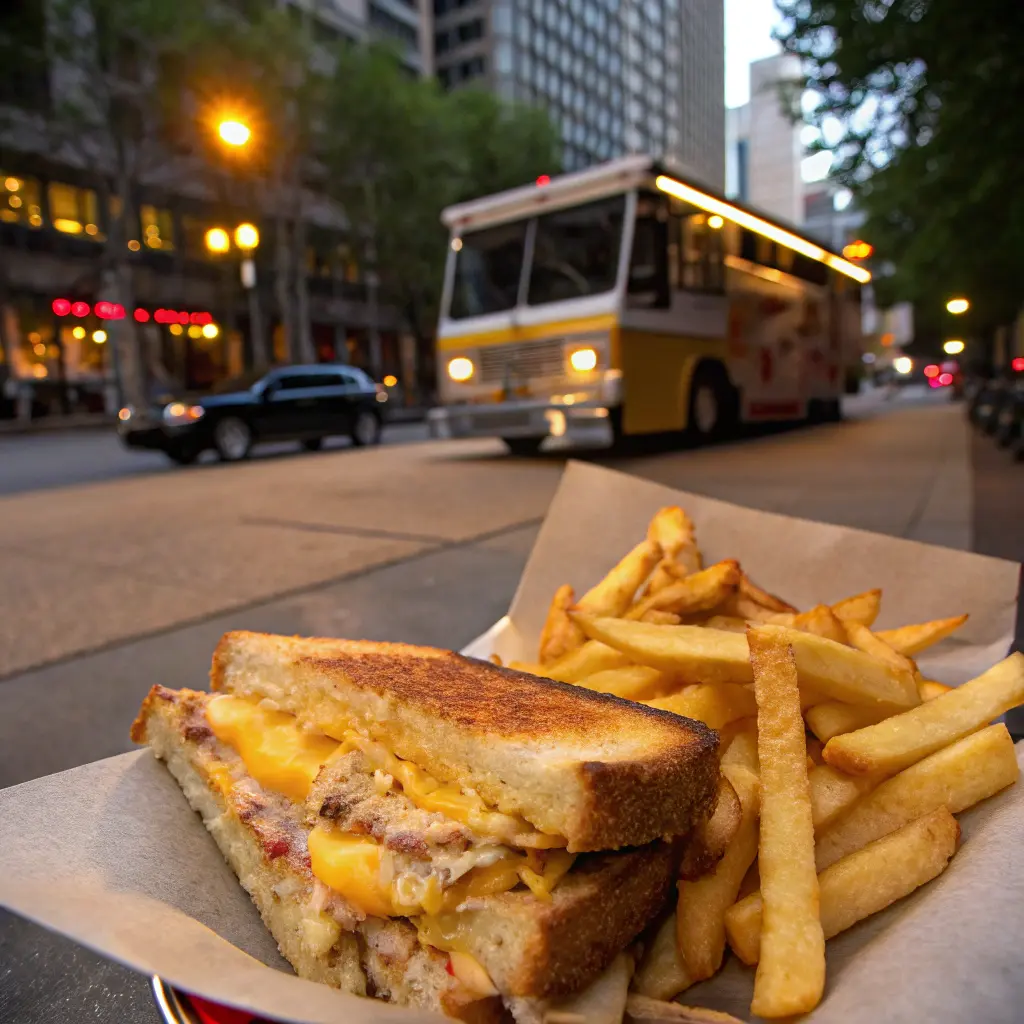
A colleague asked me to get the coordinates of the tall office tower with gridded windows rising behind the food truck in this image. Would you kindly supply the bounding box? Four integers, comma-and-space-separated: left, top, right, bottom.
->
434, 0, 725, 188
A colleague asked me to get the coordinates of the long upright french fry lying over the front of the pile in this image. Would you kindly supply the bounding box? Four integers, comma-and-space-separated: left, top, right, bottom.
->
749, 627, 827, 1017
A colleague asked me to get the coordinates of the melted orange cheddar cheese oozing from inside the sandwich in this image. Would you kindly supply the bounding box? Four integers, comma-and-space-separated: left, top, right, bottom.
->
206, 695, 574, 917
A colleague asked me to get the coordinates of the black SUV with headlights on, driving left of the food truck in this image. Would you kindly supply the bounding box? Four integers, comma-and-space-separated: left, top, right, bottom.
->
118, 365, 387, 465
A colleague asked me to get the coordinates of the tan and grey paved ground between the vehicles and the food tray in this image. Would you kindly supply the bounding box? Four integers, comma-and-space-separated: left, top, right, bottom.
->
0, 393, 1024, 1024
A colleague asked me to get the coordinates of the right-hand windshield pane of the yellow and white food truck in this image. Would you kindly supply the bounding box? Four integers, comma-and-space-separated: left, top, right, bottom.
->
526, 196, 626, 306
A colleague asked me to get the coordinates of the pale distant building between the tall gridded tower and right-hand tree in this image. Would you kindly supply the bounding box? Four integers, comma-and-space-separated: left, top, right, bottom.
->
725, 54, 804, 224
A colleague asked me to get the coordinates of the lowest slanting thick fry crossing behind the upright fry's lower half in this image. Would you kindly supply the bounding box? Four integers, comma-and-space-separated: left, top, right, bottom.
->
725, 807, 959, 965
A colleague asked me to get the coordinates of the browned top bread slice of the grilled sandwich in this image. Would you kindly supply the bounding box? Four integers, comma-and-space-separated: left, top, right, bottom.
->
210, 632, 718, 853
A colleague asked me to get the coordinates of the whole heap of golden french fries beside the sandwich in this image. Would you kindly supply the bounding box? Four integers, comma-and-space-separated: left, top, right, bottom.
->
499, 507, 1024, 1020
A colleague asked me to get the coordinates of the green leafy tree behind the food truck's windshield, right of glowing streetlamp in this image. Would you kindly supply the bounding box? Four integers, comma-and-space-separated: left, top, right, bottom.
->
322, 45, 558, 373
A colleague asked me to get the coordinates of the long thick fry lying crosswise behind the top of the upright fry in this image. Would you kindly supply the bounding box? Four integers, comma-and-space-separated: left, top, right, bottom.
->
570, 612, 921, 710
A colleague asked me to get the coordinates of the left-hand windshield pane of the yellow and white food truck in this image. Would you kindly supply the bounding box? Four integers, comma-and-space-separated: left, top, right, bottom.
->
450, 220, 527, 319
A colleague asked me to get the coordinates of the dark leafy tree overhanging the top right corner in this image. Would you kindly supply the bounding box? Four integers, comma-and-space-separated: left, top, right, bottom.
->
776, 0, 1024, 339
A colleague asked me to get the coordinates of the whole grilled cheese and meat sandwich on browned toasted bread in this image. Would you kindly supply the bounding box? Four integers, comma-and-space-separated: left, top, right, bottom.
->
132, 632, 718, 1020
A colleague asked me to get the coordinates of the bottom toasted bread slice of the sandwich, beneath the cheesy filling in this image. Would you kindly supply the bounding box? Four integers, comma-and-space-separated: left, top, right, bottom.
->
132, 686, 679, 999
